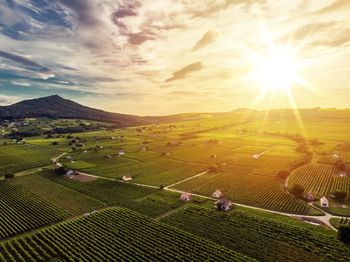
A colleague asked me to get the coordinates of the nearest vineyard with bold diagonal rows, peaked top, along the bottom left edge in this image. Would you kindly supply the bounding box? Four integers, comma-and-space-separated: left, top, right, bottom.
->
0, 208, 252, 262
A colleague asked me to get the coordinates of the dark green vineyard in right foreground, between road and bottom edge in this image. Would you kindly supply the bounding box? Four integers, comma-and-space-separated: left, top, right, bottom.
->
161, 206, 350, 261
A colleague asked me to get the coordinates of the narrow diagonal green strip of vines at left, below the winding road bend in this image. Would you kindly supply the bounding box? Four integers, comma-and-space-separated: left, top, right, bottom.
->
15, 174, 106, 216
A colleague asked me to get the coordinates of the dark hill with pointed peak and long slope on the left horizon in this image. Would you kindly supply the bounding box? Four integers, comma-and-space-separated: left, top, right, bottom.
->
0, 95, 180, 127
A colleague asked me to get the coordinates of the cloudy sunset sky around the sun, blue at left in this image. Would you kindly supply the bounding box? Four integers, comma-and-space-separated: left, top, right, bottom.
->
0, 0, 350, 115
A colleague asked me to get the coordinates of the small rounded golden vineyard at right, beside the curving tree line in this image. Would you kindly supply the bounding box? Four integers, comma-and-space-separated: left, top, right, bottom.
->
288, 164, 334, 197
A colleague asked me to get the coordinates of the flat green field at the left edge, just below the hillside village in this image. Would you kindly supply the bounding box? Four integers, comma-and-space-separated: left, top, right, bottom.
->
0, 144, 57, 176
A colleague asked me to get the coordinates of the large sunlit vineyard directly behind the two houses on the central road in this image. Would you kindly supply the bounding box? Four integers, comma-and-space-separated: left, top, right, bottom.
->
175, 167, 314, 214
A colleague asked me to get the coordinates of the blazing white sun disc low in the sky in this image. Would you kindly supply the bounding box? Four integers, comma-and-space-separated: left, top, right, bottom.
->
251, 48, 301, 92
